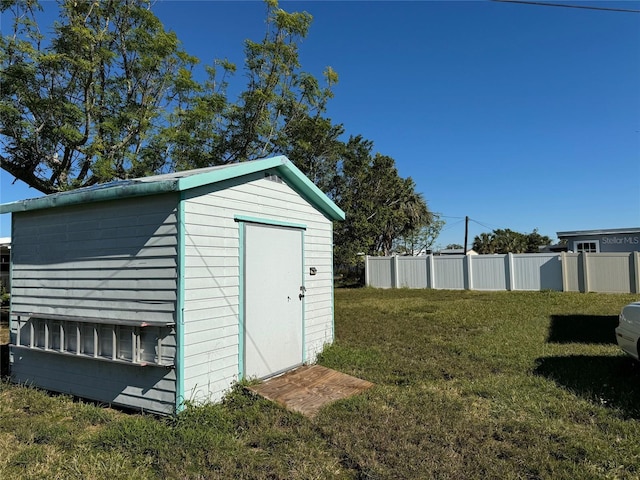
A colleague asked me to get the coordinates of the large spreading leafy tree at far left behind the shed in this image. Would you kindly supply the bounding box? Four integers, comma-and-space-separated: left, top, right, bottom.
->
0, 0, 196, 193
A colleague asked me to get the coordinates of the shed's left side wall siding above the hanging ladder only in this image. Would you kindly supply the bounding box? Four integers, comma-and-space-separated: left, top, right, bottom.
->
12, 195, 177, 322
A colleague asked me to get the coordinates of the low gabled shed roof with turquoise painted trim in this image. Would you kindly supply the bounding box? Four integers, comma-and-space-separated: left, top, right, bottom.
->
0, 156, 345, 220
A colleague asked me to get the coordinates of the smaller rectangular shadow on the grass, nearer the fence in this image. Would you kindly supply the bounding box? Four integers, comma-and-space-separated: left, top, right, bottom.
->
547, 315, 618, 345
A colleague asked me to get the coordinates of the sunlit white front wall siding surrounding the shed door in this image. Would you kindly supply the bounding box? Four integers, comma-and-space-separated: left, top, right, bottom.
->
184, 173, 333, 401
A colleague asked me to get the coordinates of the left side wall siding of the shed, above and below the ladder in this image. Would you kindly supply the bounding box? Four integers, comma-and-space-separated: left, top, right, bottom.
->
11, 194, 178, 413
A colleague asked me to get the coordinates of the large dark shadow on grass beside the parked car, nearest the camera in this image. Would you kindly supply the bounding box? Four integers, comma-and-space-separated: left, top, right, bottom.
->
534, 355, 640, 419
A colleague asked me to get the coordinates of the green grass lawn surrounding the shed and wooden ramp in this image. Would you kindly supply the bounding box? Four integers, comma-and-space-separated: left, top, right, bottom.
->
0, 289, 640, 480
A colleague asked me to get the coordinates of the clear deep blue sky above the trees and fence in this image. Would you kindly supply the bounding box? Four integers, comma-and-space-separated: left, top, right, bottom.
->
0, 0, 640, 246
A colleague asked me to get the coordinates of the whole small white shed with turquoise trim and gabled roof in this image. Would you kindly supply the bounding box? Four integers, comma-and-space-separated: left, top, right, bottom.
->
0, 157, 344, 413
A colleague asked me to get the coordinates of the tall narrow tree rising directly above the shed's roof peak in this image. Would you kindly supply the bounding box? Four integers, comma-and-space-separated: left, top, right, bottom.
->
215, 0, 342, 163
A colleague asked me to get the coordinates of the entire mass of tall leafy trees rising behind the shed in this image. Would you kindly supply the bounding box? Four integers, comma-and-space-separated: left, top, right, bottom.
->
0, 0, 430, 272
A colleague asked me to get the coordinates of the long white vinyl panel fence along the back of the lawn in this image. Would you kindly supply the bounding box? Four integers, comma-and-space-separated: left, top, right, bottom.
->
365, 252, 640, 293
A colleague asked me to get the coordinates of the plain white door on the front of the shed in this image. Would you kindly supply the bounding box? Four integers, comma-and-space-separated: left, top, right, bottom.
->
244, 223, 303, 378
